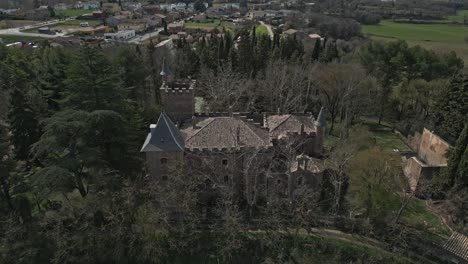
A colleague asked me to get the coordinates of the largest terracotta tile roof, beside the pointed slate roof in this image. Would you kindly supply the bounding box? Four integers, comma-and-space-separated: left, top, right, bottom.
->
182, 117, 270, 149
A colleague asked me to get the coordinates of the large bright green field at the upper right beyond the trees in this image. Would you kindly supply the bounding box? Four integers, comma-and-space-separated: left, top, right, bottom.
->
362, 19, 468, 64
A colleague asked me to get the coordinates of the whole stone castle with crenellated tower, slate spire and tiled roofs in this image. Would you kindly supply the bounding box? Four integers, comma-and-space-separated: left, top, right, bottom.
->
141, 63, 326, 200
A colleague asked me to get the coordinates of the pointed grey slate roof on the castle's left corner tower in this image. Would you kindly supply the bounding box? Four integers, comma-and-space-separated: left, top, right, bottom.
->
141, 112, 185, 152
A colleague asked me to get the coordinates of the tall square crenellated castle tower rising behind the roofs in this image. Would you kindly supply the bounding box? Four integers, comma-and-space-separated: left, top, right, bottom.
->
159, 60, 196, 123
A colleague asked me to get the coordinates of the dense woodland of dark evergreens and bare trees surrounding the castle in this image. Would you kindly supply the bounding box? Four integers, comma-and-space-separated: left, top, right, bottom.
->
0, 21, 468, 263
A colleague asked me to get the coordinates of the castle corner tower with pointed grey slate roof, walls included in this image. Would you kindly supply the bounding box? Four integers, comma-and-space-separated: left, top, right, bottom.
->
141, 112, 185, 181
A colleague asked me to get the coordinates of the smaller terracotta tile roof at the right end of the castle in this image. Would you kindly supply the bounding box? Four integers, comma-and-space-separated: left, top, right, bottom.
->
265, 114, 317, 137
